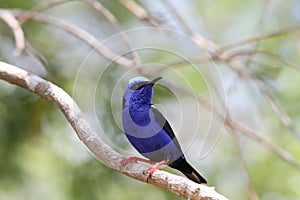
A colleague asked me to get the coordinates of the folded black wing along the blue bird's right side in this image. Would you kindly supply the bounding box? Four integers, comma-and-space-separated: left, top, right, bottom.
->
151, 106, 182, 152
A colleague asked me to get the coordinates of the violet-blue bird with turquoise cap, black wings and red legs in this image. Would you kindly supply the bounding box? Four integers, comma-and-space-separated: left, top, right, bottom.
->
121, 77, 207, 183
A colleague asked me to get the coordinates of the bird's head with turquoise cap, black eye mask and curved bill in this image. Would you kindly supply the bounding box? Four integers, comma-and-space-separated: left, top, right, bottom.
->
123, 76, 162, 107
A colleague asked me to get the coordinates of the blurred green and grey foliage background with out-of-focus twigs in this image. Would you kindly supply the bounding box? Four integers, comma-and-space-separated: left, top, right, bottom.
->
0, 0, 300, 200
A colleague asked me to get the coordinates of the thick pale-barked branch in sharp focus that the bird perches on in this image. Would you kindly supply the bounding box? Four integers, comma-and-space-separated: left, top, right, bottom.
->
0, 61, 227, 200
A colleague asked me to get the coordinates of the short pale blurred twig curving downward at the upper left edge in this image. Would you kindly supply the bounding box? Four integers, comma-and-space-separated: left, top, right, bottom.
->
0, 9, 25, 56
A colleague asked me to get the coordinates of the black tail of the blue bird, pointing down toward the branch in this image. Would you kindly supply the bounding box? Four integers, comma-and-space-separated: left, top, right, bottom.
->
169, 157, 207, 183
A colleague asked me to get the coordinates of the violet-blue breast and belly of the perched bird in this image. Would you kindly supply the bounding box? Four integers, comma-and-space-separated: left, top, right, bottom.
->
122, 108, 182, 162
